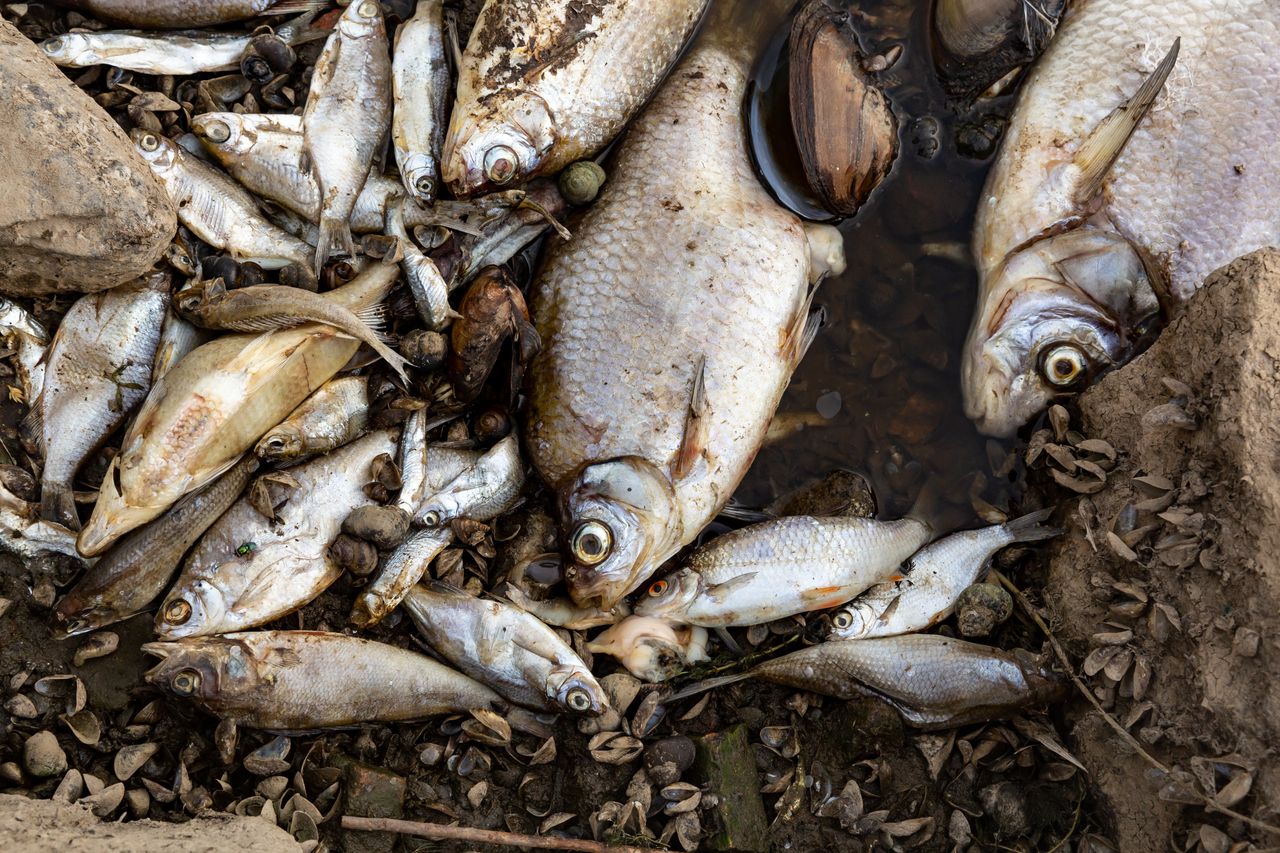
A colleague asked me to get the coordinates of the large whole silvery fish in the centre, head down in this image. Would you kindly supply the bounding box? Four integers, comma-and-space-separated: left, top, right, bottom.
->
526, 0, 844, 610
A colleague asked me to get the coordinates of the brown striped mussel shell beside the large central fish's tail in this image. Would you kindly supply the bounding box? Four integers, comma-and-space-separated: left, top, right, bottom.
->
788, 0, 897, 216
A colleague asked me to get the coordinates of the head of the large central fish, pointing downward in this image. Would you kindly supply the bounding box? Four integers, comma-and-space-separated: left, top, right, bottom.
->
563, 456, 680, 610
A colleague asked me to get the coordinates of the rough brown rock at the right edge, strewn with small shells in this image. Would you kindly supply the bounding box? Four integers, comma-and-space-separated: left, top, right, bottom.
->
1046, 244, 1280, 850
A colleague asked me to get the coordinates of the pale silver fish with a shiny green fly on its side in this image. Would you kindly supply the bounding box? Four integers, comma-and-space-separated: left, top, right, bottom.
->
156, 429, 397, 639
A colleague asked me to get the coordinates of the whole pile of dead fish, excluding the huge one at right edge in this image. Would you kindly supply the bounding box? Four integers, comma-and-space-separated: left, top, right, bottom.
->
0, 0, 1111, 768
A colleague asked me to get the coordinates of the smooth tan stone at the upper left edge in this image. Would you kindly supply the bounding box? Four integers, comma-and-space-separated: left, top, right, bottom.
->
0, 20, 177, 296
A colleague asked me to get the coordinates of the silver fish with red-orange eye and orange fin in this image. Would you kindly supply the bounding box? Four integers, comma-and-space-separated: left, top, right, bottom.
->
635, 515, 933, 628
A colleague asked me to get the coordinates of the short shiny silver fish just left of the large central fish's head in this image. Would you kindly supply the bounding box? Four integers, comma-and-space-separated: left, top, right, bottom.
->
413, 434, 525, 528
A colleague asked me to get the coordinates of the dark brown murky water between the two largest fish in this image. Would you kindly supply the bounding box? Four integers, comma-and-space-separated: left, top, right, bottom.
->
737, 0, 1012, 521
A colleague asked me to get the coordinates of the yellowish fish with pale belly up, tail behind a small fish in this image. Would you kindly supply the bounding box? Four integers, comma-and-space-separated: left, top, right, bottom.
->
79, 264, 396, 556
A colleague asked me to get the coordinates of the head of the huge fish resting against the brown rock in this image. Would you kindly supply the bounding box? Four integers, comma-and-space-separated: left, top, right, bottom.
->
961, 228, 1160, 437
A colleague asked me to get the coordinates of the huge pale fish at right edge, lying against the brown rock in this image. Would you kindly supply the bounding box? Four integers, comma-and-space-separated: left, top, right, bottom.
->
963, 0, 1280, 435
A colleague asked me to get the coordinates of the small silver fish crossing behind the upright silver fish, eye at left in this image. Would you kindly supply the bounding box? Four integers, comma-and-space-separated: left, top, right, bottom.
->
191, 113, 409, 234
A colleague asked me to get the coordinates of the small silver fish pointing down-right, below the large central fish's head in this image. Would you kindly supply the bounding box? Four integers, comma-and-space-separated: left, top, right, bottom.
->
404, 580, 609, 717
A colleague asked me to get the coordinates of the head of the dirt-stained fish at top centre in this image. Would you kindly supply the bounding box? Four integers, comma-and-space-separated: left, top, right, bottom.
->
442, 92, 556, 199
